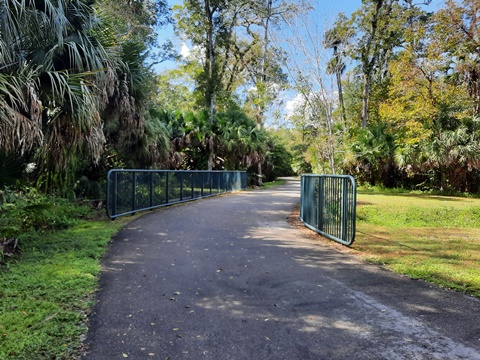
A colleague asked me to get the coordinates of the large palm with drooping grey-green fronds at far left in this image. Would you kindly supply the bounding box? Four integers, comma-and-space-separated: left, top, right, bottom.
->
0, 0, 120, 194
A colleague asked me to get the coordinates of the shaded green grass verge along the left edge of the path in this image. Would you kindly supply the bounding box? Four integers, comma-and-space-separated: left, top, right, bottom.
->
0, 218, 131, 360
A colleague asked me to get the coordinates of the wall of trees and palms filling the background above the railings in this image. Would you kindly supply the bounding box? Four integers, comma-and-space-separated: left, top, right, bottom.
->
0, 0, 480, 196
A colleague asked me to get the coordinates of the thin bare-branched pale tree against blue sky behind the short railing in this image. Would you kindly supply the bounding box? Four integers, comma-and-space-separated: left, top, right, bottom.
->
282, 3, 341, 174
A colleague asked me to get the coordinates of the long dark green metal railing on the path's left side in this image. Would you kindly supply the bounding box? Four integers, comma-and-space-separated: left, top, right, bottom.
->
106, 169, 247, 219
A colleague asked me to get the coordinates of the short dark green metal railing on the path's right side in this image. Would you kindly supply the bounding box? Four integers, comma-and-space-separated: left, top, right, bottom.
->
300, 174, 357, 245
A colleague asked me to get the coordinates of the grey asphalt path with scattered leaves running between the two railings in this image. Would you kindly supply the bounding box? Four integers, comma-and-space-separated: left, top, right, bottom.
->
85, 181, 480, 360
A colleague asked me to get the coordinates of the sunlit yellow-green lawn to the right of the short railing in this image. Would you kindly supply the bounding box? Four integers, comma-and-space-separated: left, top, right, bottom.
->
352, 192, 480, 297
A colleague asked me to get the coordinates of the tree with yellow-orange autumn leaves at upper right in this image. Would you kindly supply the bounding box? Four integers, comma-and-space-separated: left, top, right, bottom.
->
380, 11, 440, 144
